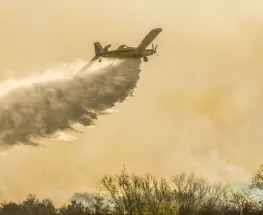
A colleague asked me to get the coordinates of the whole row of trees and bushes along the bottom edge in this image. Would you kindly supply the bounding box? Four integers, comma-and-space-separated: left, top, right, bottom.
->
0, 165, 263, 215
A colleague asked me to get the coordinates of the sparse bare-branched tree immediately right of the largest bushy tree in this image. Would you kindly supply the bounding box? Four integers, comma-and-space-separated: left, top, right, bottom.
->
173, 173, 227, 215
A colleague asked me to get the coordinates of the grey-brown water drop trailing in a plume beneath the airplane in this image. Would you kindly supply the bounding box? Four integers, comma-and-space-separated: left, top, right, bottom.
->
0, 59, 141, 145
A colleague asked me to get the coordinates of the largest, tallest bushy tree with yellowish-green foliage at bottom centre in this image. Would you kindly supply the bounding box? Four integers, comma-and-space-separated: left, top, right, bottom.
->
101, 169, 176, 215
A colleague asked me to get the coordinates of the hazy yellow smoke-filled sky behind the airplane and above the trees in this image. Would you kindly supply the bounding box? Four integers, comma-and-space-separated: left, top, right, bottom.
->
0, 0, 263, 203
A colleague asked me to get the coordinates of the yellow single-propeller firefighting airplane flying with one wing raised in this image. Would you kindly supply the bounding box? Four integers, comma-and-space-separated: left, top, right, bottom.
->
91, 28, 162, 62
